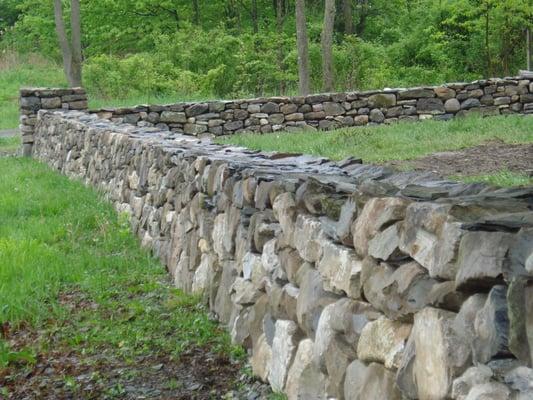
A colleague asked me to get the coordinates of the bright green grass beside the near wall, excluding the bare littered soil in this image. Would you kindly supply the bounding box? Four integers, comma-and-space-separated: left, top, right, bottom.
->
0, 158, 239, 369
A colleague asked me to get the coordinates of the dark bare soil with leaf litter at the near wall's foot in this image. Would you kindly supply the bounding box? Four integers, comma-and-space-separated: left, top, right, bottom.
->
0, 292, 271, 400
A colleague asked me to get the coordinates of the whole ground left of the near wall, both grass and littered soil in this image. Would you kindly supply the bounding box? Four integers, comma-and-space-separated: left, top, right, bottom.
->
0, 158, 264, 399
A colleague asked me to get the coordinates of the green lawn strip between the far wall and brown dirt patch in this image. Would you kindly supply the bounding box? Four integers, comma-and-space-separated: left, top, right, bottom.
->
218, 116, 533, 163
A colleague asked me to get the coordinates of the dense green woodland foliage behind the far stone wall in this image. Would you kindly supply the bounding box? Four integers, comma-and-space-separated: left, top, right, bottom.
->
0, 0, 533, 98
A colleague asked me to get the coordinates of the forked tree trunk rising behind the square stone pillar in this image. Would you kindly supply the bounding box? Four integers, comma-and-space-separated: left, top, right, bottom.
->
54, 0, 82, 87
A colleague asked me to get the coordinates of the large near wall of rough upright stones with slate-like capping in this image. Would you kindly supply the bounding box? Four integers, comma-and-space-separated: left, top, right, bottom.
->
34, 111, 533, 400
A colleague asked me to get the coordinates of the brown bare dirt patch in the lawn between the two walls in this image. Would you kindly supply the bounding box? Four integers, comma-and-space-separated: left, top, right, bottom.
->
388, 141, 533, 177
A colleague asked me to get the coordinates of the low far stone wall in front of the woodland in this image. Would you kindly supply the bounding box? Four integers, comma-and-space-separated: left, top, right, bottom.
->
92, 77, 533, 135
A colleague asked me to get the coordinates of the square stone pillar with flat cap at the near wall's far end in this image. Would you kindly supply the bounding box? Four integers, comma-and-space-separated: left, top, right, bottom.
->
19, 88, 88, 157
